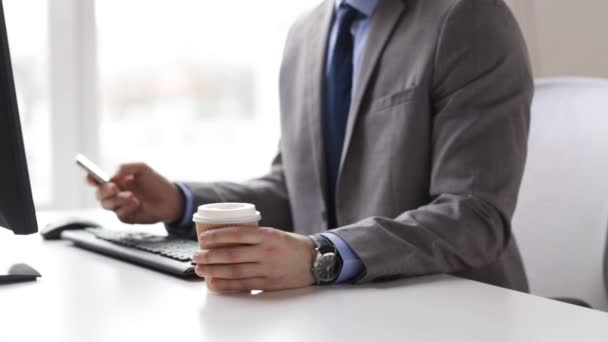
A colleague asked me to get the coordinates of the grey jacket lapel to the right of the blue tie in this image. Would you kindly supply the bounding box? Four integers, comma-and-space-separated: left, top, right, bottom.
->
338, 0, 405, 171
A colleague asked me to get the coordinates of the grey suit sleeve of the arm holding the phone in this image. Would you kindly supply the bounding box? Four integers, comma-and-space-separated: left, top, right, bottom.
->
176, 153, 292, 234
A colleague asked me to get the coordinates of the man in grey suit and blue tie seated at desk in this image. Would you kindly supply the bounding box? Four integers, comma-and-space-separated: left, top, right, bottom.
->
89, 0, 533, 291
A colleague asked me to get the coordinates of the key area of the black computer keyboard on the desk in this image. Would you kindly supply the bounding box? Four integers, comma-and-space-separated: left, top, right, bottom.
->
85, 228, 198, 261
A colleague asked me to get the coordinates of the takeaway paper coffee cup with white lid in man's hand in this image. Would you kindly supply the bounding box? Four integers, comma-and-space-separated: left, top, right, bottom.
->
192, 203, 262, 248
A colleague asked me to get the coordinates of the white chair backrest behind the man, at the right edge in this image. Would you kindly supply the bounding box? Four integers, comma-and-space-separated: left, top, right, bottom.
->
513, 78, 608, 311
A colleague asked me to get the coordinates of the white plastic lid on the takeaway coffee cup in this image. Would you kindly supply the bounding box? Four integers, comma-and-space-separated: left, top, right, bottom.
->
192, 202, 262, 224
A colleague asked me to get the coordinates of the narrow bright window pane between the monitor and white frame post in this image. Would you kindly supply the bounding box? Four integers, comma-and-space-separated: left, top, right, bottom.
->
3, 0, 53, 206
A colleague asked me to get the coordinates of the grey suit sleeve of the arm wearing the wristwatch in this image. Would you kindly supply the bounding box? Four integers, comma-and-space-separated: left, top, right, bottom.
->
334, 0, 533, 282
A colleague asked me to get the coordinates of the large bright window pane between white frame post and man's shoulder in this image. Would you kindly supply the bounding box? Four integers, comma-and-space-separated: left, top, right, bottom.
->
96, 0, 317, 180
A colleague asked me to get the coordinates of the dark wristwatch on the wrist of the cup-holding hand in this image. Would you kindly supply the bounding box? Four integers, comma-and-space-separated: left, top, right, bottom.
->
310, 234, 342, 285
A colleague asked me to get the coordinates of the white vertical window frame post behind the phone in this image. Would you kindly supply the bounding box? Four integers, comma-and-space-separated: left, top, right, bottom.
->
46, 0, 99, 210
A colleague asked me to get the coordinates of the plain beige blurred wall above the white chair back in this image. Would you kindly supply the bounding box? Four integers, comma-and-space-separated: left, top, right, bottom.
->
505, 0, 608, 77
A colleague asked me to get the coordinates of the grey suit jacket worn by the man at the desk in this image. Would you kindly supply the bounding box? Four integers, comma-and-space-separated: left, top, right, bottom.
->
179, 0, 533, 291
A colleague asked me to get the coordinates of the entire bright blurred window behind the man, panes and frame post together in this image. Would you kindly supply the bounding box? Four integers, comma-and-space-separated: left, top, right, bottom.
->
3, 0, 318, 209
